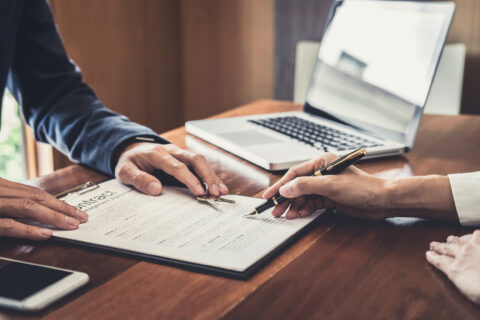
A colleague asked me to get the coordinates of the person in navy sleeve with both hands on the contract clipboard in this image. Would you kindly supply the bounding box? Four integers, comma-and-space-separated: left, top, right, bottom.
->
0, 0, 228, 240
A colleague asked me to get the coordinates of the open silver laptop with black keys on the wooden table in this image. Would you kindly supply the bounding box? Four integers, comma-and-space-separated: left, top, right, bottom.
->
186, 0, 455, 170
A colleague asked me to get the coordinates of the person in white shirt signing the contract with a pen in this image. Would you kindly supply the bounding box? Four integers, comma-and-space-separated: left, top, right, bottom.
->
263, 153, 480, 304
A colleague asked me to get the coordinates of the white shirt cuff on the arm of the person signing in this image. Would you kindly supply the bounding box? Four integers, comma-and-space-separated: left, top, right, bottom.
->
448, 171, 480, 226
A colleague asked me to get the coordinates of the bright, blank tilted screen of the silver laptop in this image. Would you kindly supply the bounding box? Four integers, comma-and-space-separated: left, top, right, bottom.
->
306, 0, 454, 145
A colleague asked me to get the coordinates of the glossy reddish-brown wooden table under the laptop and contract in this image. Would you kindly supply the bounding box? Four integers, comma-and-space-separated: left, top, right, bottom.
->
0, 101, 480, 319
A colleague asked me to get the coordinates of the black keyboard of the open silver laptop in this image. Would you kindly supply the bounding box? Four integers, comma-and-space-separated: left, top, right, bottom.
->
248, 116, 380, 151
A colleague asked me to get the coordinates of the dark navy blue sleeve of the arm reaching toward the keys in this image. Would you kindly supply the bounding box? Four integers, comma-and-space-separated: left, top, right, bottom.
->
0, 0, 168, 175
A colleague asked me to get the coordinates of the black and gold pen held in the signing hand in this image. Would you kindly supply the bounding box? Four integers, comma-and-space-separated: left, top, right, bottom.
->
248, 148, 367, 216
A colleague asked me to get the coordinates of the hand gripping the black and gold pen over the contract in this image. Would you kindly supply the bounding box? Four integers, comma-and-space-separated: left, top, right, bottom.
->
263, 153, 387, 219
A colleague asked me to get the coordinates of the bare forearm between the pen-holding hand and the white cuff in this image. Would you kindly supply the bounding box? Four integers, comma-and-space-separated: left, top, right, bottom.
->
385, 175, 458, 221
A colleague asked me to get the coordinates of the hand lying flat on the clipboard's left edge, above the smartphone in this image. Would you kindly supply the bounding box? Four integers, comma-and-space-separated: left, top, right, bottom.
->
0, 178, 88, 240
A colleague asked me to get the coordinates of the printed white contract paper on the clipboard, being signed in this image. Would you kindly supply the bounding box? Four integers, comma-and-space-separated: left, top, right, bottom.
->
53, 180, 322, 275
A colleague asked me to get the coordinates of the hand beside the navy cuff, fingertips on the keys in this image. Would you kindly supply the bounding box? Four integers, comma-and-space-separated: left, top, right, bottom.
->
115, 142, 228, 196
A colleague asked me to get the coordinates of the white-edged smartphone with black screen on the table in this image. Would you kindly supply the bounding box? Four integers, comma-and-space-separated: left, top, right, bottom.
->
0, 257, 89, 311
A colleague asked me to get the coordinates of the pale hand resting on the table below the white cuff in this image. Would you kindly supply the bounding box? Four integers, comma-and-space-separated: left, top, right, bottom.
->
426, 230, 480, 304
